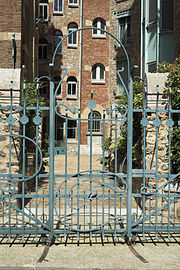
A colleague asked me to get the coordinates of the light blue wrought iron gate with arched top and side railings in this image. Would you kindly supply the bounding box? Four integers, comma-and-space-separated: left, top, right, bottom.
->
0, 27, 180, 241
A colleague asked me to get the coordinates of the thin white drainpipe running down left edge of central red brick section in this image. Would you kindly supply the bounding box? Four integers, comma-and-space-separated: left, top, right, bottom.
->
78, 0, 83, 110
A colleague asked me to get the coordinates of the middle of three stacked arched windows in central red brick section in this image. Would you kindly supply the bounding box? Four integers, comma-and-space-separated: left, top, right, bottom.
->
91, 64, 105, 84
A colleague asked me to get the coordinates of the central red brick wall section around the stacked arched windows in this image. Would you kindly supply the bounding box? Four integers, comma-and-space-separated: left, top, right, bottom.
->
81, 0, 110, 144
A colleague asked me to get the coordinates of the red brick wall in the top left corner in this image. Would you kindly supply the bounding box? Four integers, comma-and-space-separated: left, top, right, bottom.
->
0, 0, 22, 68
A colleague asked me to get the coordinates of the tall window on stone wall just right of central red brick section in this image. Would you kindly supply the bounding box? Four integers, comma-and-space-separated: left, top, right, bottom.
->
118, 16, 131, 45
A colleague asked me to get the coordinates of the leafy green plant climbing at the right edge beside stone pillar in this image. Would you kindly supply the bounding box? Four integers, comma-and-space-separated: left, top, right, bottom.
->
157, 58, 180, 173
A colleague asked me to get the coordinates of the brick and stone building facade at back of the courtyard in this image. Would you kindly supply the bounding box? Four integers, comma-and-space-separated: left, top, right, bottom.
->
38, 0, 140, 152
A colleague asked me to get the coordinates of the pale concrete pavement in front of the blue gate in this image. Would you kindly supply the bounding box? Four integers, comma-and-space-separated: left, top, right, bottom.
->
0, 239, 180, 270
